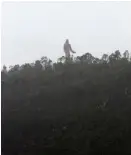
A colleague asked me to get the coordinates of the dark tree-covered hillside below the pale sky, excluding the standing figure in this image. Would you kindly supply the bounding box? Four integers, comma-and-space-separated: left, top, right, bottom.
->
1, 50, 131, 155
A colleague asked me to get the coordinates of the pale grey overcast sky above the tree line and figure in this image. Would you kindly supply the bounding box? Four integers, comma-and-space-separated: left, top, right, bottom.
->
2, 1, 131, 66
